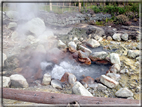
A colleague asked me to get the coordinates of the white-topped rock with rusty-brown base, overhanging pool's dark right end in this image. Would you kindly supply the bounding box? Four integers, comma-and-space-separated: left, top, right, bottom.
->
89, 51, 108, 61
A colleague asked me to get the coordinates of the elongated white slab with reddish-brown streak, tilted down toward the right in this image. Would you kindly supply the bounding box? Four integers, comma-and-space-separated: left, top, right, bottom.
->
100, 75, 119, 88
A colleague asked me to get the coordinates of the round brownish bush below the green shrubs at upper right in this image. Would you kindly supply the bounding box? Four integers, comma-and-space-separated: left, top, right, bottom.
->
116, 15, 129, 24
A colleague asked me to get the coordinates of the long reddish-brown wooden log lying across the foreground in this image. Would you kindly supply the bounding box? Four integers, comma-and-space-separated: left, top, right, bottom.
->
0, 88, 139, 105
